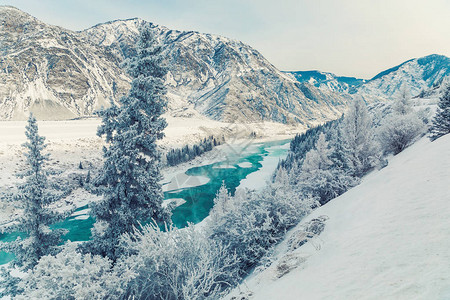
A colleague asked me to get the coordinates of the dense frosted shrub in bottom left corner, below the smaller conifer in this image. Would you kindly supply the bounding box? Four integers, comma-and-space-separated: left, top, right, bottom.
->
15, 244, 128, 299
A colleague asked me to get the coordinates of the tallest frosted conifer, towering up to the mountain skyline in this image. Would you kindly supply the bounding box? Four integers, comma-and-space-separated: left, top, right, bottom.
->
85, 26, 169, 260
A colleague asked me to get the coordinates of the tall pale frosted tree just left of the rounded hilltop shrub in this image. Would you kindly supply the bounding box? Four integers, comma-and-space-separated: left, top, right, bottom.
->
340, 98, 381, 177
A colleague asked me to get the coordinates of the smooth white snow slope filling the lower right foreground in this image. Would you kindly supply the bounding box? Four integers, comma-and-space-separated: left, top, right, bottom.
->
227, 135, 450, 299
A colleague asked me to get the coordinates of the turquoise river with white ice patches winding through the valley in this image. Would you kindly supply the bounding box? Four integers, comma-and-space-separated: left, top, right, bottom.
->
0, 140, 289, 264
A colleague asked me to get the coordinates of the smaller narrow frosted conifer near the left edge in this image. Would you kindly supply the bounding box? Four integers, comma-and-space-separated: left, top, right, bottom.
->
0, 114, 65, 270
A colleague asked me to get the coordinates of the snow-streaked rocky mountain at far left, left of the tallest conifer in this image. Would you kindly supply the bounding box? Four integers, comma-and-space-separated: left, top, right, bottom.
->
0, 6, 129, 120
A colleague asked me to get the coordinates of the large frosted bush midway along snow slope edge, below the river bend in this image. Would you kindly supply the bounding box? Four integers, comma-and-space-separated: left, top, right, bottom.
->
207, 180, 313, 275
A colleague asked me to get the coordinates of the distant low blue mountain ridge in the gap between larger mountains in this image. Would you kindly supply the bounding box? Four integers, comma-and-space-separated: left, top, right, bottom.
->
286, 70, 366, 94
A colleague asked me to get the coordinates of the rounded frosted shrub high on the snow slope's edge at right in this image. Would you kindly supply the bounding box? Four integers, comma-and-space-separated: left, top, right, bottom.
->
378, 113, 426, 155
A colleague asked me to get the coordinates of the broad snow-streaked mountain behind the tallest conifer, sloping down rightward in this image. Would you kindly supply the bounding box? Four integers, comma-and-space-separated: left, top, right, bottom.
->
84, 19, 350, 123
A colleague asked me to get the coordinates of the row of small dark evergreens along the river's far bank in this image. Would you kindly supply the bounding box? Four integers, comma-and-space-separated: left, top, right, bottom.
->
166, 135, 225, 166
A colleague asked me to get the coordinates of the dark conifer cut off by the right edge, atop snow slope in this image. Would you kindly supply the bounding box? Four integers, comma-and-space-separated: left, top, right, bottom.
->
430, 83, 450, 141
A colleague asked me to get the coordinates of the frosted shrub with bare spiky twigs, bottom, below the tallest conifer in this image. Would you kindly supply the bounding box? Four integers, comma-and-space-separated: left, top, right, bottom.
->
119, 225, 238, 300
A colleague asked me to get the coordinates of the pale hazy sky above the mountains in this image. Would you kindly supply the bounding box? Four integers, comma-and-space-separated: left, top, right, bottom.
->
0, 0, 450, 78
